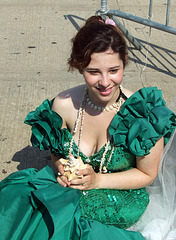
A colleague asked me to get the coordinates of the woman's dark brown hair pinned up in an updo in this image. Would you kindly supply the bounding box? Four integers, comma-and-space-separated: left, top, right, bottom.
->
68, 16, 127, 73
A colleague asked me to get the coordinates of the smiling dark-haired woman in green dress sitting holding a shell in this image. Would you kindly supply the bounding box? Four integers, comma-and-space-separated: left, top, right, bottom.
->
0, 17, 176, 240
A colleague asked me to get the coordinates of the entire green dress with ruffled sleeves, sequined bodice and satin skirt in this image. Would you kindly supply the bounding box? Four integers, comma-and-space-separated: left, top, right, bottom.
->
0, 88, 176, 240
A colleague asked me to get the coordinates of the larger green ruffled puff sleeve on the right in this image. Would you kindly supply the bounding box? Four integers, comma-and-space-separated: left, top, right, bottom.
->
109, 87, 176, 156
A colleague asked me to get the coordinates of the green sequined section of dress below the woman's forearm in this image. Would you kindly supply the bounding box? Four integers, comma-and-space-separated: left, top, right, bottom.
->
80, 189, 149, 229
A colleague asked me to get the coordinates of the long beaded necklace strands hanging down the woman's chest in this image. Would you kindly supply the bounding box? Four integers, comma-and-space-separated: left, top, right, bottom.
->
69, 88, 125, 173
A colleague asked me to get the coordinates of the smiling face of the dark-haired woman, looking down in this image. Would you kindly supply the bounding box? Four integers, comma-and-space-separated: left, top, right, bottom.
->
83, 49, 124, 105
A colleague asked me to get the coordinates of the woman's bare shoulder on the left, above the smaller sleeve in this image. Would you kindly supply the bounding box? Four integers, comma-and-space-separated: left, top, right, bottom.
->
52, 85, 85, 127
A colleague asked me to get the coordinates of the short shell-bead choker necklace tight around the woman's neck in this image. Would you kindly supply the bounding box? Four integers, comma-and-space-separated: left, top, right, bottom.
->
86, 88, 124, 112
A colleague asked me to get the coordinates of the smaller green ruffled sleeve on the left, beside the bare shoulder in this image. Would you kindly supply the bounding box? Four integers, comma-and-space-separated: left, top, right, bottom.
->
24, 100, 64, 156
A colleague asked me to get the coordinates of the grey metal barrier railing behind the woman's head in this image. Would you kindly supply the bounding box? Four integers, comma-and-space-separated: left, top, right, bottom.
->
96, 0, 176, 50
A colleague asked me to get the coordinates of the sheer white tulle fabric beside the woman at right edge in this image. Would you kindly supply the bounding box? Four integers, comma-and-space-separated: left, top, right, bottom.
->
129, 131, 176, 240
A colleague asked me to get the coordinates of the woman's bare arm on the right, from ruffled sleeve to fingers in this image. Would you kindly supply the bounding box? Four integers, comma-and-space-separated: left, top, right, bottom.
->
70, 138, 164, 190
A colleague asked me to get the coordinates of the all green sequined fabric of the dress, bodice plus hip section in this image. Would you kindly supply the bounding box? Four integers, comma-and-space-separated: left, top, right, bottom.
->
63, 129, 149, 229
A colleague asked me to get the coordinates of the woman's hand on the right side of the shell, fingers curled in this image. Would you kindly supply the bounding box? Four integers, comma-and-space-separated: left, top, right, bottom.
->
69, 164, 99, 190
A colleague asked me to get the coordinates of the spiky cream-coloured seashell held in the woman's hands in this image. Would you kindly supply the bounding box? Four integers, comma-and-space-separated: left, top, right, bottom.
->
60, 155, 86, 181
